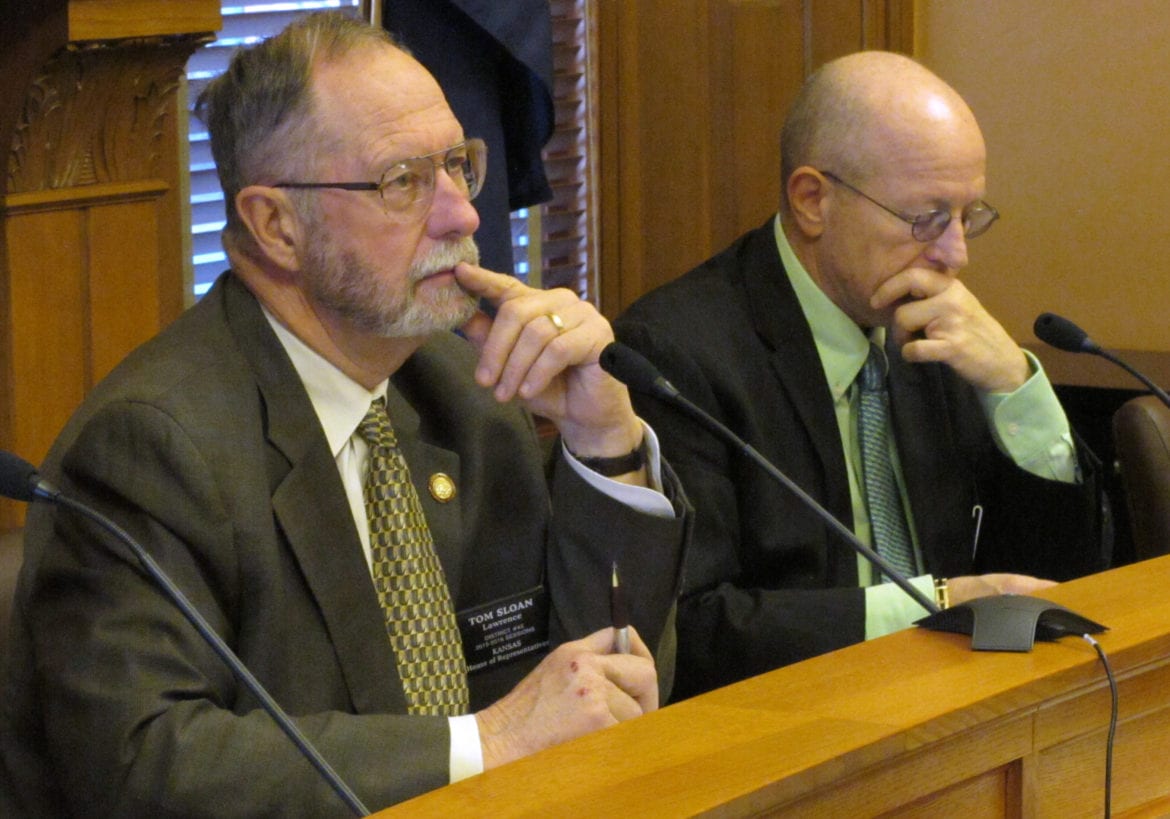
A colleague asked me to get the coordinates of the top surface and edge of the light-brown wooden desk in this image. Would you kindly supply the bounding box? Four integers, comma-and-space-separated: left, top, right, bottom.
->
376, 557, 1170, 818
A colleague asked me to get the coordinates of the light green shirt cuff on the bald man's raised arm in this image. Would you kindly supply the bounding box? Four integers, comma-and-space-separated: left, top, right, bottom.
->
979, 350, 1080, 483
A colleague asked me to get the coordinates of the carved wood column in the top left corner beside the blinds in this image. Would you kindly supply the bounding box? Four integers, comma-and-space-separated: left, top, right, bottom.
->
0, 0, 220, 528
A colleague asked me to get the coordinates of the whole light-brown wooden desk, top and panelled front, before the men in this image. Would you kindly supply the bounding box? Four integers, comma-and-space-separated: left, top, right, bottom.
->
376, 557, 1170, 819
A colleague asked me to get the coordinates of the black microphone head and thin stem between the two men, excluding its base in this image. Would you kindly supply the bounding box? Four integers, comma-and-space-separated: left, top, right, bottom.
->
599, 342, 941, 614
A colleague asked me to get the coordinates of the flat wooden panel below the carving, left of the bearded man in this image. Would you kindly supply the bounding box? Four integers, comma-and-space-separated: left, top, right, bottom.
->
6, 180, 167, 498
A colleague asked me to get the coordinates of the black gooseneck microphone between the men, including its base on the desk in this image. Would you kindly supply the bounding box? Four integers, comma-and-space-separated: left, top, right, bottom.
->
599, 342, 1106, 652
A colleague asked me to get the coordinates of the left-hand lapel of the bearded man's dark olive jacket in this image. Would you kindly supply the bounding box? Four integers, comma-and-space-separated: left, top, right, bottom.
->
225, 277, 405, 714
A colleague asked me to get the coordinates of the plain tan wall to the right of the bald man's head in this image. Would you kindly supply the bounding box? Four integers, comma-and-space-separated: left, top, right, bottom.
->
916, 0, 1170, 388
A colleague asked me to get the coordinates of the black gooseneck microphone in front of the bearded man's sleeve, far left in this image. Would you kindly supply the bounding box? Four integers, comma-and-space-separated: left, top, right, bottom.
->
0, 449, 370, 817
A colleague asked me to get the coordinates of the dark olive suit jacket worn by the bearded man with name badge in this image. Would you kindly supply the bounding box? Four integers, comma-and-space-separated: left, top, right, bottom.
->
0, 275, 683, 817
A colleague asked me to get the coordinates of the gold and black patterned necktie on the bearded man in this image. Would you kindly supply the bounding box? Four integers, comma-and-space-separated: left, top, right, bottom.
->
358, 398, 468, 716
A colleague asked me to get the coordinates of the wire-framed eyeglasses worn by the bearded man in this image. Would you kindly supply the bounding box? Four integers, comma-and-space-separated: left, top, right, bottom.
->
273, 139, 488, 221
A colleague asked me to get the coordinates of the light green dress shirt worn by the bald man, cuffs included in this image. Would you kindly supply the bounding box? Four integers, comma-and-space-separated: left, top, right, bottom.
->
773, 216, 1080, 640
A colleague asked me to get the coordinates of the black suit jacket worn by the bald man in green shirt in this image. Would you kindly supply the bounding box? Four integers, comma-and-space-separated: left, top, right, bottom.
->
615, 220, 1109, 698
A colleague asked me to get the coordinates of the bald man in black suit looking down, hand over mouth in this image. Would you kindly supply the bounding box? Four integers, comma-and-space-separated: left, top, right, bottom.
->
615, 51, 1112, 698
